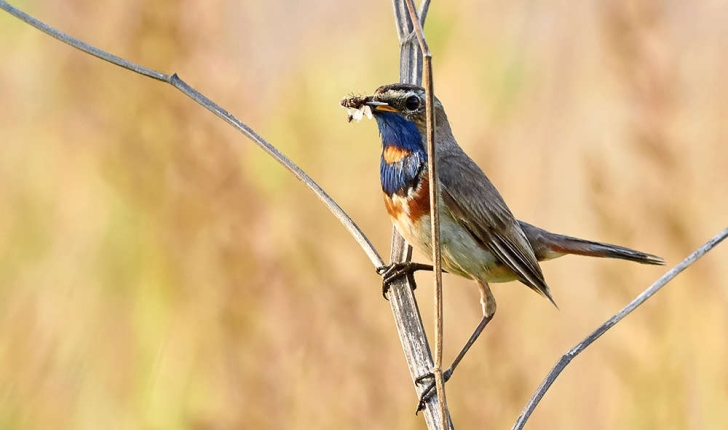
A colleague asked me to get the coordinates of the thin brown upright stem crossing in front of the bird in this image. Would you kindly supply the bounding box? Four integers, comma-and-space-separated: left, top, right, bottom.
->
406, 0, 447, 428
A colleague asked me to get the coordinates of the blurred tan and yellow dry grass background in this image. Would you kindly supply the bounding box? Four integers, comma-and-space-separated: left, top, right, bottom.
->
0, 0, 728, 430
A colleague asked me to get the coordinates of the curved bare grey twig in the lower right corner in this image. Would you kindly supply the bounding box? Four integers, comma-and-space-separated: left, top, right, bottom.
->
512, 228, 728, 430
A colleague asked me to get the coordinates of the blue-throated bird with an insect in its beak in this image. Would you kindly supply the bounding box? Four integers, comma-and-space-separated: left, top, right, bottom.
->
341, 84, 664, 408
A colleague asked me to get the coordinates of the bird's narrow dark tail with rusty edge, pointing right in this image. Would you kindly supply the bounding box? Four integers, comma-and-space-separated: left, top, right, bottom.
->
520, 221, 665, 265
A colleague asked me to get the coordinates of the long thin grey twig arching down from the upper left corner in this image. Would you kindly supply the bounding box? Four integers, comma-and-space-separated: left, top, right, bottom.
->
0, 0, 384, 268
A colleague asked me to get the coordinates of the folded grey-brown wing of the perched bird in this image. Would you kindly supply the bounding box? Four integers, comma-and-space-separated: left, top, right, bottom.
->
438, 152, 556, 305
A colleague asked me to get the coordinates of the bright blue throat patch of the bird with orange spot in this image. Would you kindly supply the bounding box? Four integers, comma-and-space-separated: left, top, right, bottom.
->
374, 112, 427, 196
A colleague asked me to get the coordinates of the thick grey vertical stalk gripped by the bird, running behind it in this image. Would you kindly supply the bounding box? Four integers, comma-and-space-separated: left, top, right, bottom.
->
389, 0, 452, 429
